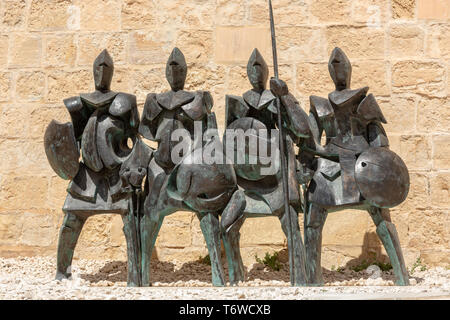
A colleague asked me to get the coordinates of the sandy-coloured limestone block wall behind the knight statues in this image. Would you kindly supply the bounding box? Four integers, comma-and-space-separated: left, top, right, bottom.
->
0, 0, 450, 268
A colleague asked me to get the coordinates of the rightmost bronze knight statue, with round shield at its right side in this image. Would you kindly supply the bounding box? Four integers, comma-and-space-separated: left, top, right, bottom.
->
302, 48, 409, 285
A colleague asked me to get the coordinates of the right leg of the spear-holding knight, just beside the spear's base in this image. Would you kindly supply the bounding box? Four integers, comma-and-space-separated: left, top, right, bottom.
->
279, 206, 306, 286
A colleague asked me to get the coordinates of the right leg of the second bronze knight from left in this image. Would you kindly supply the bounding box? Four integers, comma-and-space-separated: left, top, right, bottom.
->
197, 213, 225, 287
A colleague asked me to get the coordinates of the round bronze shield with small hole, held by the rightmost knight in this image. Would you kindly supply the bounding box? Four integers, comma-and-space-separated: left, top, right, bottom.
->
355, 148, 409, 208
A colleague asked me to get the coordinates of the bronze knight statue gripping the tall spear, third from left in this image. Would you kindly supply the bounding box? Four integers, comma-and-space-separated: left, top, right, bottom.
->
221, 49, 310, 286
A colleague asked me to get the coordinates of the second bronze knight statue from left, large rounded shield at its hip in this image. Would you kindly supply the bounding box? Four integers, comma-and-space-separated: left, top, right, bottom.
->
139, 48, 236, 286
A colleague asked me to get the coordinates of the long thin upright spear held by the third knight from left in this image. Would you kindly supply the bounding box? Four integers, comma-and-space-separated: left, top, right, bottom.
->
269, 0, 294, 285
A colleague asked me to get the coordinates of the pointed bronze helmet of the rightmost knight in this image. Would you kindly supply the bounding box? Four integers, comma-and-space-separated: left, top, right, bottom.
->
328, 48, 352, 91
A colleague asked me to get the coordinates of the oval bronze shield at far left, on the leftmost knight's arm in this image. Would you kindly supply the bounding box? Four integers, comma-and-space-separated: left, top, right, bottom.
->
44, 120, 80, 180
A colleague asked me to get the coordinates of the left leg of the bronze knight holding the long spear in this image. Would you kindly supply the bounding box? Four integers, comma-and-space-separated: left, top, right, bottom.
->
220, 190, 246, 285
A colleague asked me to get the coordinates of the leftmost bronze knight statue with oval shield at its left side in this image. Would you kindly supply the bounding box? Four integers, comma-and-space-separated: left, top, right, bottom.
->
44, 50, 152, 286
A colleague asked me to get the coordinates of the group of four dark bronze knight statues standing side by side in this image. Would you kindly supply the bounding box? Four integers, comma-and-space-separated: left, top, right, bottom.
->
45, 44, 409, 286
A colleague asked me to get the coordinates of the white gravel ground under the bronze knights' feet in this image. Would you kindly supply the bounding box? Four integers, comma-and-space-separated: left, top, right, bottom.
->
0, 257, 450, 300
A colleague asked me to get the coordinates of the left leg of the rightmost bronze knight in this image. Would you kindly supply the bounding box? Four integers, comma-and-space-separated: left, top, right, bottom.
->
304, 203, 328, 286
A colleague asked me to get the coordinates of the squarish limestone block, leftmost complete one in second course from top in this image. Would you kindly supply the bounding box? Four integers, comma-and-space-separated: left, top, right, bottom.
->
9, 34, 42, 68
